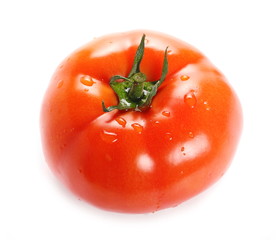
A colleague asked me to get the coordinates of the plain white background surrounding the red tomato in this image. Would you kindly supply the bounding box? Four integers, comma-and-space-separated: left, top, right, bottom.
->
0, 0, 276, 240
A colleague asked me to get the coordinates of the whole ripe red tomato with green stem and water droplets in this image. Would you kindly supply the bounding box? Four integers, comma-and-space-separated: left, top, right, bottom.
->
41, 31, 242, 213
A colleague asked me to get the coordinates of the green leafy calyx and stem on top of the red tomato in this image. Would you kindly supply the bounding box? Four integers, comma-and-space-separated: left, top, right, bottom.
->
102, 34, 168, 112
